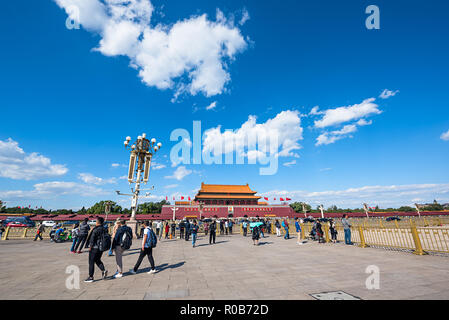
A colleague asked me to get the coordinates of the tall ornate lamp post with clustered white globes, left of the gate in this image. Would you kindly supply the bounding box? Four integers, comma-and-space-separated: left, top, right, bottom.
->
117, 133, 162, 235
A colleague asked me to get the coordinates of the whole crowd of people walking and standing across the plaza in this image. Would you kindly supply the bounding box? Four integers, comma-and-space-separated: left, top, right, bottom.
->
25, 215, 352, 282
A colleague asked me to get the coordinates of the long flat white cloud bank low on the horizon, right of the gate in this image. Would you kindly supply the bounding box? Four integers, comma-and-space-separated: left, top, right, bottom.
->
263, 183, 449, 208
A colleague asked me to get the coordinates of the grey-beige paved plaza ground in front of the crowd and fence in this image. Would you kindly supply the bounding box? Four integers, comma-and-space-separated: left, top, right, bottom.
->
0, 235, 449, 300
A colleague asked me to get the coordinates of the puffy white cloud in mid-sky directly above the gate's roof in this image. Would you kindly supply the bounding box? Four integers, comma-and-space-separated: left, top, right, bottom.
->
203, 110, 303, 158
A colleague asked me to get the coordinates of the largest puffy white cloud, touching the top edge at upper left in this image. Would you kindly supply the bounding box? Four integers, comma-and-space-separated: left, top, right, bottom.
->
55, 0, 249, 99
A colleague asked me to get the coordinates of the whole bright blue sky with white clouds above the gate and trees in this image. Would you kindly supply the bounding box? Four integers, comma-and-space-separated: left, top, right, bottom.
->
0, 0, 449, 208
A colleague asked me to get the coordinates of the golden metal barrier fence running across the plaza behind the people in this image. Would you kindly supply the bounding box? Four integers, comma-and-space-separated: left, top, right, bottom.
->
2, 217, 449, 255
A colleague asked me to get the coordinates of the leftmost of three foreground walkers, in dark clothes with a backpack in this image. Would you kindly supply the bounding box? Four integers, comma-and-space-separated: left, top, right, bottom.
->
84, 217, 111, 282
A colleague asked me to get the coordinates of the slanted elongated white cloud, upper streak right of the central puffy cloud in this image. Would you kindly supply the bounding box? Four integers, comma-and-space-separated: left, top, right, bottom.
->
315, 98, 382, 128
